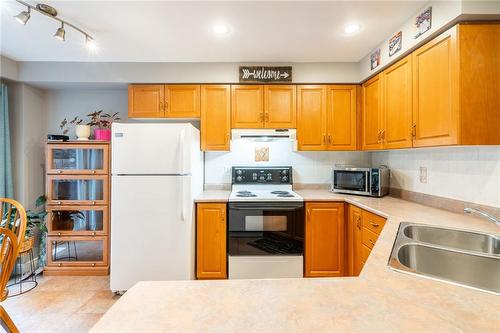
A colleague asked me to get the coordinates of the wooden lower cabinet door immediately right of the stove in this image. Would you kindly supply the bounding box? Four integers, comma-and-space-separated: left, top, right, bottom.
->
304, 202, 345, 277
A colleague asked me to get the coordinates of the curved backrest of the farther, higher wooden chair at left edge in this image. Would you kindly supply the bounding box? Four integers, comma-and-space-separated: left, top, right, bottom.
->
0, 198, 28, 246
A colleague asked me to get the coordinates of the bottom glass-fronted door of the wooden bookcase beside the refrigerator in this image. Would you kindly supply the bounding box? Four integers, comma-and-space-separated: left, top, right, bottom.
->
47, 236, 108, 267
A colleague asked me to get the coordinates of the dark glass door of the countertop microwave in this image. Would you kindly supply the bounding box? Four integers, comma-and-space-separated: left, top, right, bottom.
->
332, 169, 371, 195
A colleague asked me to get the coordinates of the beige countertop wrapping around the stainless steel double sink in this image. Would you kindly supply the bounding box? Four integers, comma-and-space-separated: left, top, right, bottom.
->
92, 190, 500, 333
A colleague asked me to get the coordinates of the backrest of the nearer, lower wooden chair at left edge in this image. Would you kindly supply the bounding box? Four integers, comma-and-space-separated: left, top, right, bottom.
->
0, 228, 19, 302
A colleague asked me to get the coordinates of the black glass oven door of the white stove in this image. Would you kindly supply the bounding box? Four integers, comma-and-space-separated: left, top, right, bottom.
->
228, 202, 304, 256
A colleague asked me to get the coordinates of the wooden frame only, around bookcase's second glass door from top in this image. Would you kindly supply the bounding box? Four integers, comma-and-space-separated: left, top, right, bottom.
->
46, 175, 109, 206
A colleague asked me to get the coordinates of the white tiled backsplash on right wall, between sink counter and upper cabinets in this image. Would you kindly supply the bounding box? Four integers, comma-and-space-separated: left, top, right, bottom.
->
372, 147, 500, 207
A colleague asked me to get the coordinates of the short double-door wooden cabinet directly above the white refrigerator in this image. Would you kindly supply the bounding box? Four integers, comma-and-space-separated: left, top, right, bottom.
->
128, 84, 200, 118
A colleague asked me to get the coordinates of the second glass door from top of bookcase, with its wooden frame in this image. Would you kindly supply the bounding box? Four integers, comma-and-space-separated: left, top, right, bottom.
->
47, 175, 108, 205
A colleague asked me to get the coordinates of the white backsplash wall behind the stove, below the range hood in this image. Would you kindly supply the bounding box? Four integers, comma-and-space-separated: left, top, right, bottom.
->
205, 140, 371, 185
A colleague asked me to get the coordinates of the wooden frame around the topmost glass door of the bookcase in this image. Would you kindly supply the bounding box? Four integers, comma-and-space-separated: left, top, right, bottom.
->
45, 143, 109, 175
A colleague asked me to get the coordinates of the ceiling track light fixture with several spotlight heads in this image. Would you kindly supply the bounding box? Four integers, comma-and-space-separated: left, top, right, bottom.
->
14, 0, 97, 51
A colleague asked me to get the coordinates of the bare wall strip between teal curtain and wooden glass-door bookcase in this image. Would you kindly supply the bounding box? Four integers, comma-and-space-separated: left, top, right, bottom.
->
8, 83, 46, 209
